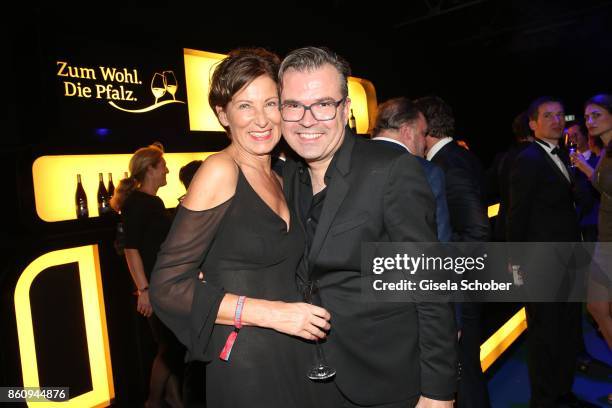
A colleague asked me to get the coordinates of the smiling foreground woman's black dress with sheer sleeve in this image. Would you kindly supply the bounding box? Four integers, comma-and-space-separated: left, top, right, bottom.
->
151, 171, 317, 408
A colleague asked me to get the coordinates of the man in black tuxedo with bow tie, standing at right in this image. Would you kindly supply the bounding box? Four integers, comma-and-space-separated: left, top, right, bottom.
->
506, 97, 587, 407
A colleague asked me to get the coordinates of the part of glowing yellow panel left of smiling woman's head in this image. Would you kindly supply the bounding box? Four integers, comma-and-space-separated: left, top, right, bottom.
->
183, 48, 225, 132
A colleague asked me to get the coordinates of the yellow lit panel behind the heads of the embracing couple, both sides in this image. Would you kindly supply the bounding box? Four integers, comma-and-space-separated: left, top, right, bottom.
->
183, 48, 377, 133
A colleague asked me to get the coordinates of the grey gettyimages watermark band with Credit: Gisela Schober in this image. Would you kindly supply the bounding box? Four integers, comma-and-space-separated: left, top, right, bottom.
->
361, 242, 612, 302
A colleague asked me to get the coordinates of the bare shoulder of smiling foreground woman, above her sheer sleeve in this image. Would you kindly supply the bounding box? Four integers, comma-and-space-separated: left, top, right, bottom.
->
182, 151, 238, 211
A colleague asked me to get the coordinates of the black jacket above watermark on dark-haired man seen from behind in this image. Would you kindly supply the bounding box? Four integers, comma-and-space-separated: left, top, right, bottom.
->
431, 141, 489, 242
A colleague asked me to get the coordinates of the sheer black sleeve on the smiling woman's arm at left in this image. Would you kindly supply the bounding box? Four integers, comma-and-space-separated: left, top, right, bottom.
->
149, 199, 232, 361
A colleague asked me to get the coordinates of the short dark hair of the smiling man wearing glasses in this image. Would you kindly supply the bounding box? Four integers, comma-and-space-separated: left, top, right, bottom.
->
278, 47, 351, 98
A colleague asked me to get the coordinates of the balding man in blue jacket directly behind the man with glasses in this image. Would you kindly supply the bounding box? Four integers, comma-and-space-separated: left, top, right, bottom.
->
372, 97, 451, 242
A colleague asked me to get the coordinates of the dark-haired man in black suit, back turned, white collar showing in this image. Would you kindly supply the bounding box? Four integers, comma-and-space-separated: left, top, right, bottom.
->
416, 96, 490, 408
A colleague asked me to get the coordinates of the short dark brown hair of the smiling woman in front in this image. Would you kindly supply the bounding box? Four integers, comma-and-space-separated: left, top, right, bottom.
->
208, 48, 280, 130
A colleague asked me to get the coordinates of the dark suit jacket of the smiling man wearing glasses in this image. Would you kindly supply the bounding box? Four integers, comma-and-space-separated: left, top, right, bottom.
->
283, 130, 457, 405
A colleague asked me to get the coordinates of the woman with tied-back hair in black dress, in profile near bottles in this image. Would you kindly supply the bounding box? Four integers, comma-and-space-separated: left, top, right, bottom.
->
111, 144, 185, 408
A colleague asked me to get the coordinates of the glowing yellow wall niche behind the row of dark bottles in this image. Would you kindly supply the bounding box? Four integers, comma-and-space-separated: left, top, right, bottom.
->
32, 152, 212, 222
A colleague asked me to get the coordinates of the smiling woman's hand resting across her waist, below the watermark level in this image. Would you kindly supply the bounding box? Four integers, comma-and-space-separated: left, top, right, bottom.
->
266, 302, 331, 340
